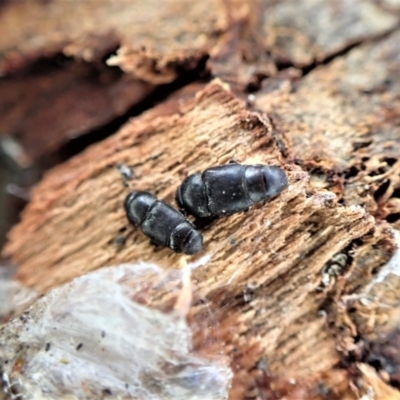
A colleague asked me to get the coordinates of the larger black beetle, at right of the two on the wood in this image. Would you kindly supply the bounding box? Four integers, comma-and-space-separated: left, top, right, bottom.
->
175, 163, 288, 218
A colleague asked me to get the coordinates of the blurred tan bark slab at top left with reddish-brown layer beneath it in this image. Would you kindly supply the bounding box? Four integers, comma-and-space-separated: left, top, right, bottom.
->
0, 1, 226, 162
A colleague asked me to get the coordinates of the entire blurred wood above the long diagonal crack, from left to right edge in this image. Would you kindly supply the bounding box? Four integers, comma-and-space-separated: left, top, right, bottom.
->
0, 0, 398, 160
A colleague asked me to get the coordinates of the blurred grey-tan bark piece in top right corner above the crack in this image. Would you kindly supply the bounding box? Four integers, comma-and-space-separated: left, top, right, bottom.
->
260, 0, 399, 67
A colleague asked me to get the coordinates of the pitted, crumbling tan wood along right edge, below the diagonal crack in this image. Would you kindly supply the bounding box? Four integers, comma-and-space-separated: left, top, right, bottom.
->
250, 32, 400, 398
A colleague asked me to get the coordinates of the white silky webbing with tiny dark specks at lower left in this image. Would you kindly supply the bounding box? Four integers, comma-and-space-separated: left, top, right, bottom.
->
0, 263, 232, 400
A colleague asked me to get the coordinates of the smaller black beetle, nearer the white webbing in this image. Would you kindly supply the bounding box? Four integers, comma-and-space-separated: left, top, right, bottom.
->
124, 192, 203, 254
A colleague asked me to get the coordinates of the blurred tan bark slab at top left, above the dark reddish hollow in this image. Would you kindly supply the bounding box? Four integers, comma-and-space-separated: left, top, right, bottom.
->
0, 0, 226, 83
